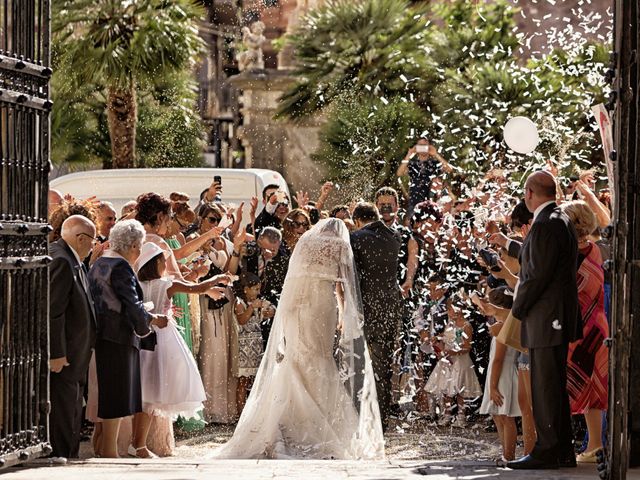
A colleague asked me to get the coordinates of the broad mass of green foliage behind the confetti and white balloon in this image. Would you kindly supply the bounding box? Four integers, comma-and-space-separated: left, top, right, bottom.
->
280, 0, 606, 193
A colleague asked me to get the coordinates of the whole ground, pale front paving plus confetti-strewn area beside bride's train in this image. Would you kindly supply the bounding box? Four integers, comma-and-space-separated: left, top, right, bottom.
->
2, 420, 640, 480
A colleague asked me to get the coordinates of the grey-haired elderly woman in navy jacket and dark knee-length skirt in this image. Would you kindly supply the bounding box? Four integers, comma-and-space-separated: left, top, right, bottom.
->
89, 220, 168, 458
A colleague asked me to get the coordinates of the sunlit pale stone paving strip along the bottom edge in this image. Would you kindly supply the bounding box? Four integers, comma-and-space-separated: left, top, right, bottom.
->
2, 459, 640, 480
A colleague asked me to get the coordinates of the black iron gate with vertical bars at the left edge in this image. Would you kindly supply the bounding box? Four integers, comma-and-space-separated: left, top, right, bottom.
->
0, 0, 51, 467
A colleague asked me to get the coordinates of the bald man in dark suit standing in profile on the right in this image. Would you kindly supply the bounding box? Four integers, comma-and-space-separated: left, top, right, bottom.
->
508, 171, 582, 469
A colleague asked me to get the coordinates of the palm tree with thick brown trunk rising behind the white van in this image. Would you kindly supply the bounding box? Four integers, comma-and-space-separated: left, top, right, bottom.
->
52, 0, 204, 168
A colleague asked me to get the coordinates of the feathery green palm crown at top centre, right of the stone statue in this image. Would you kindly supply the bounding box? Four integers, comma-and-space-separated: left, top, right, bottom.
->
278, 0, 428, 120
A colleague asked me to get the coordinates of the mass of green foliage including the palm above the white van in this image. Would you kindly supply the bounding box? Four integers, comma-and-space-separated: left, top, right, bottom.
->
52, 0, 204, 168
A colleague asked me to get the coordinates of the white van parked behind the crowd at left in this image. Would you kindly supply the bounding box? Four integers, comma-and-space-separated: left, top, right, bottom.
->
50, 168, 289, 219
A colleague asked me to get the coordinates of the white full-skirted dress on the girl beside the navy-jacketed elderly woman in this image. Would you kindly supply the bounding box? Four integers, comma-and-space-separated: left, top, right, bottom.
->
140, 278, 206, 420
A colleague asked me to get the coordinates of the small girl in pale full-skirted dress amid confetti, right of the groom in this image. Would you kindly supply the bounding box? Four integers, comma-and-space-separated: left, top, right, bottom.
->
425, 298, 482, 427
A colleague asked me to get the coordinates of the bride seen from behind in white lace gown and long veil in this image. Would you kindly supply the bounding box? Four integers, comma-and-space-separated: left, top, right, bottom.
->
214, 218, 384, 459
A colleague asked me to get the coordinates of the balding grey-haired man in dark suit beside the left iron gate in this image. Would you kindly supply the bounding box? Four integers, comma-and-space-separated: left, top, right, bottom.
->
49, 215, 96, 458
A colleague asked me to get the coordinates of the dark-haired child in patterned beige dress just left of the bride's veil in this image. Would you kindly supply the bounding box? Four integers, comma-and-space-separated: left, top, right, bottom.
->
234, 273, 269, 414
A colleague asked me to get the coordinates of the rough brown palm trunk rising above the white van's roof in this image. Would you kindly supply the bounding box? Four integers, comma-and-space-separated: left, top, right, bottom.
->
107, 85, 138, 168
